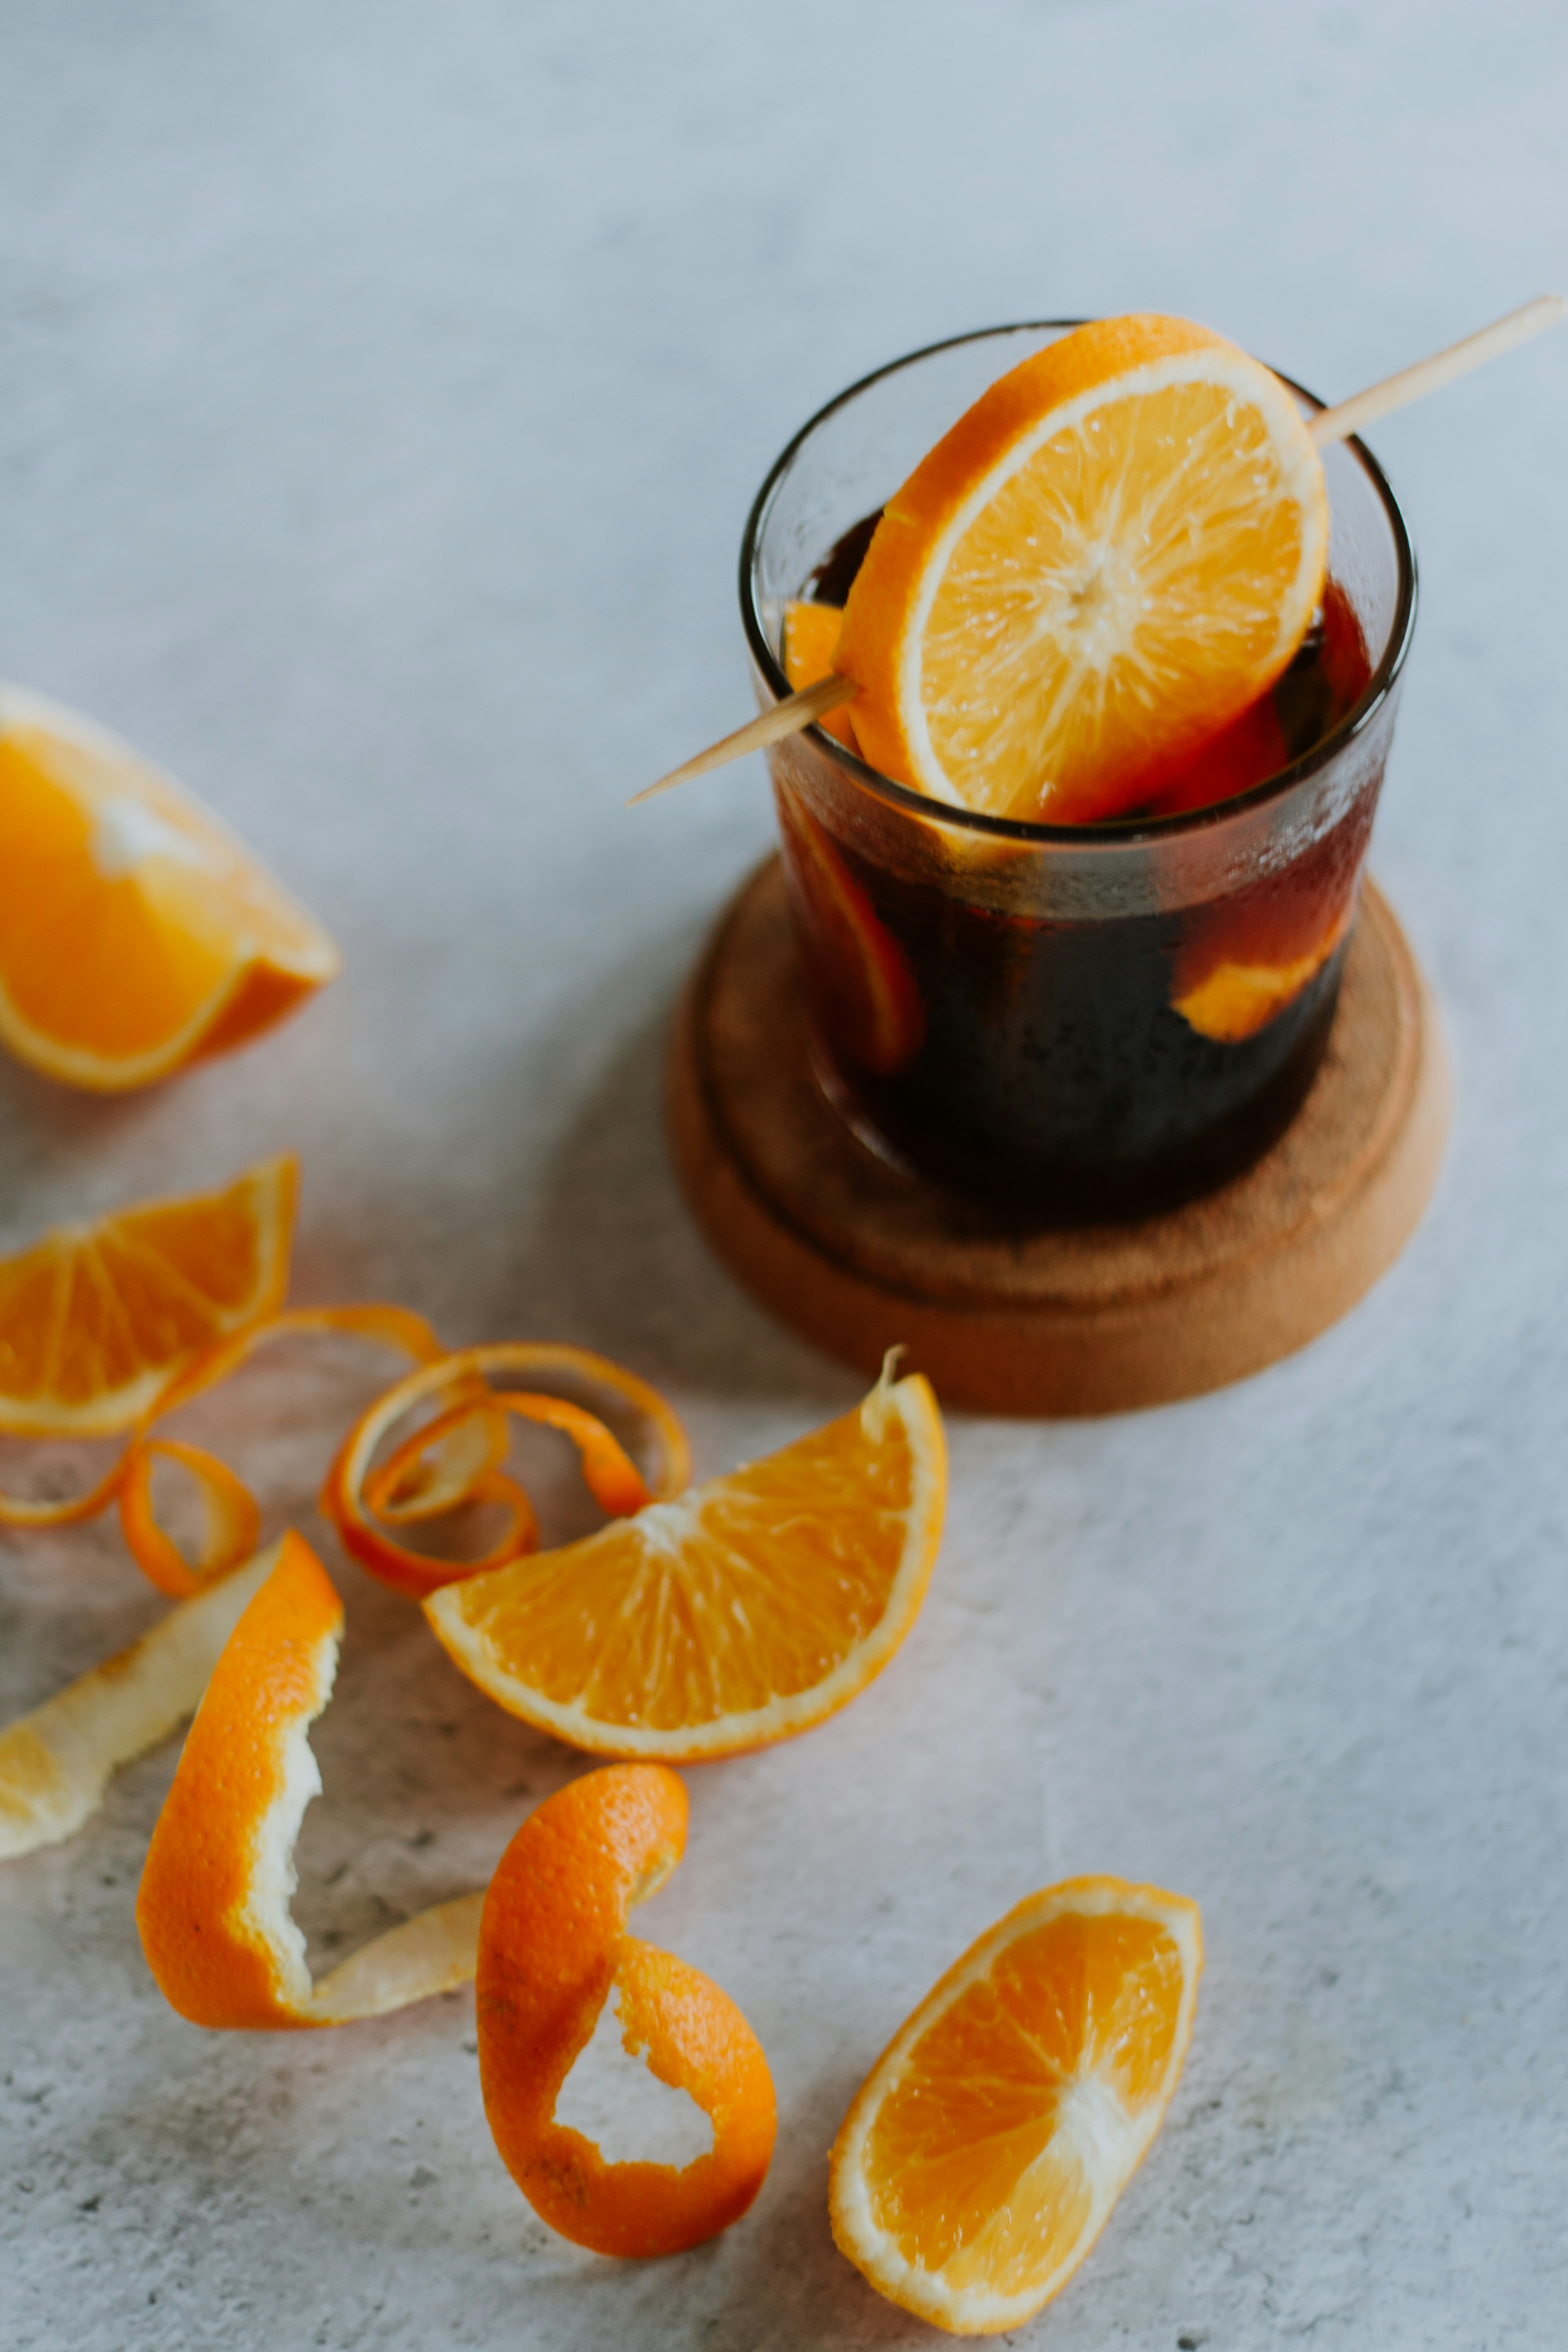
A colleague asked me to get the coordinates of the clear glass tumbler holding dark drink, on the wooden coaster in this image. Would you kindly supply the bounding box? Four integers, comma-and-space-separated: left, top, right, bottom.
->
740, 320, 1415, 1223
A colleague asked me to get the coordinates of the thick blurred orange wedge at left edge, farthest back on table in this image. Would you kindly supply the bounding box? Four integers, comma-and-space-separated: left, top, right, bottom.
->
0, 687, 338, 1094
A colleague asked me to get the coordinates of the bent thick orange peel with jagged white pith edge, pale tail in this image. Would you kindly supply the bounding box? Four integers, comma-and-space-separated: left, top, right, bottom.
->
137, 1534, 484, 2030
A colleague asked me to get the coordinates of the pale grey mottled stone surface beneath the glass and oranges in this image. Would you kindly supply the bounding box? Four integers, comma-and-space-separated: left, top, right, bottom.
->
0, 0, 1568, 2352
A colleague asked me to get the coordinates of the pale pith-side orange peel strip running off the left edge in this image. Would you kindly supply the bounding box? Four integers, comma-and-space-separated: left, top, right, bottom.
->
0, 1545, 277, 1861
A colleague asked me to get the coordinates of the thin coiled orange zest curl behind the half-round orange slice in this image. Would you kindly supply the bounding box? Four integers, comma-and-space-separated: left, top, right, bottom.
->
322, 1341, 691, 1599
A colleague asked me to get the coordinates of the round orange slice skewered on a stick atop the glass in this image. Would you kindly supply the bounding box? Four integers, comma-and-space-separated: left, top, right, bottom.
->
832, 315, 1328, 823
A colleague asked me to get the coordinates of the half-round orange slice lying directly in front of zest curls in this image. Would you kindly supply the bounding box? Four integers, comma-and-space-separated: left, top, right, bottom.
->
426, 1371, 947, 1762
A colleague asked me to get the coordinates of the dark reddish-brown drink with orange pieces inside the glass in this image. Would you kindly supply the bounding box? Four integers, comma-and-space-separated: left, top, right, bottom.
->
776, 515, 1375, 1218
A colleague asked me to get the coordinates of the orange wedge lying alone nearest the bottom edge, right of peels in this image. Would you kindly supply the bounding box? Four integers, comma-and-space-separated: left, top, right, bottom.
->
830, 1879, 1204, 2336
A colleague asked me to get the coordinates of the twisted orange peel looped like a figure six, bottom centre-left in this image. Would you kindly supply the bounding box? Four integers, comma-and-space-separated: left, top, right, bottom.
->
475, 1764, 776, 2258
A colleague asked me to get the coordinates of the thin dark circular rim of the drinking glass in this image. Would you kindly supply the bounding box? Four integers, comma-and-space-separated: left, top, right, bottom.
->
740, 318, 1417, 849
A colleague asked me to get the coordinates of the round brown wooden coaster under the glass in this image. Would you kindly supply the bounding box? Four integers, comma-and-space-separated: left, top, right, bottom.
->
670, 858, 1450, 1414
